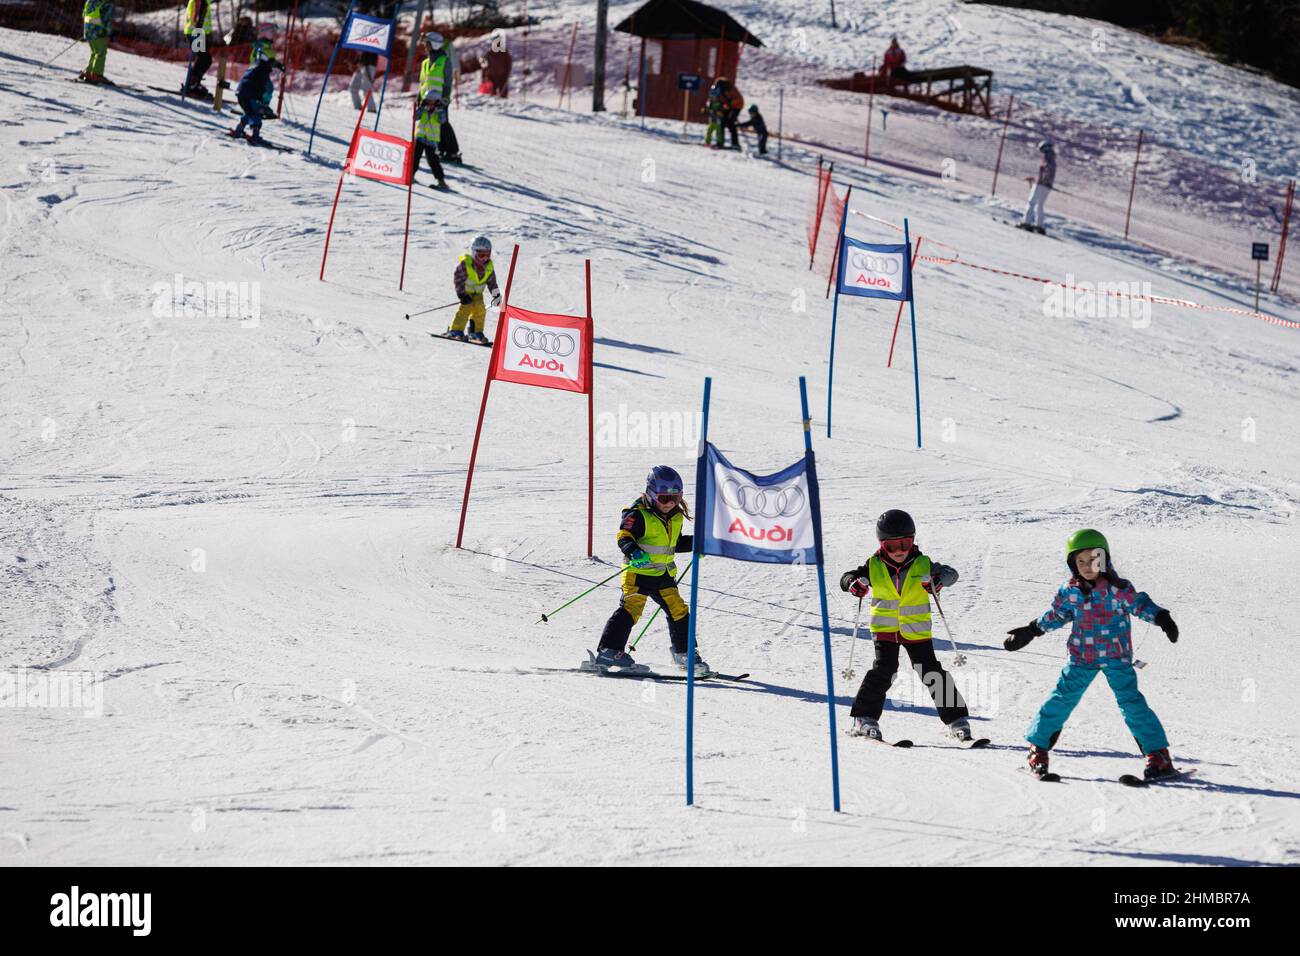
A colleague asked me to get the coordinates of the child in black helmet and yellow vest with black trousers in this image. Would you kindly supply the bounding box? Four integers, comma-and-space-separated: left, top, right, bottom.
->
840, 510, 971, 741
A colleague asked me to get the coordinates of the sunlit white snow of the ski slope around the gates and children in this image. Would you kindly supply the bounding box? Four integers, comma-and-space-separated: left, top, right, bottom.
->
0, 27, 1300, 865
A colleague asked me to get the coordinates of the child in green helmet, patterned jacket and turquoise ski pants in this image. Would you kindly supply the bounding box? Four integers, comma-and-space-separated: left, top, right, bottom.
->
1004, 528, 1178, 780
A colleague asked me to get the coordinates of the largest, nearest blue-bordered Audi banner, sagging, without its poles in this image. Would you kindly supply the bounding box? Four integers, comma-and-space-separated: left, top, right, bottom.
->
697, 442, 822, 564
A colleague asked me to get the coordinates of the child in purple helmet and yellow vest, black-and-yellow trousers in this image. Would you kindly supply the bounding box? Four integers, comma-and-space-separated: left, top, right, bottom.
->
594, 464, 710, 676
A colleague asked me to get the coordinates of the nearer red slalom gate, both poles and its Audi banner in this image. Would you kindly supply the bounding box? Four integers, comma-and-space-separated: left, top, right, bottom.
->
456, 246, 595, 557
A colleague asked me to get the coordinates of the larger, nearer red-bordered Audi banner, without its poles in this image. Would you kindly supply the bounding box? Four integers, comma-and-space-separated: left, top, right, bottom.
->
491, 304, 592, 393
